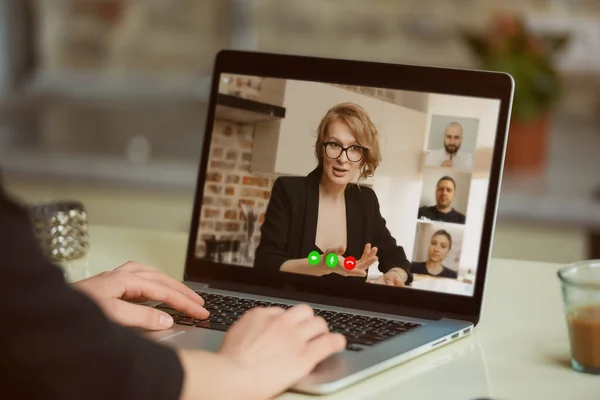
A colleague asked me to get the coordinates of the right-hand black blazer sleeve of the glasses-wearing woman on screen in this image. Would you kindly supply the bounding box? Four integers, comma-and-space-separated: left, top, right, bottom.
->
371, 190, 413, 284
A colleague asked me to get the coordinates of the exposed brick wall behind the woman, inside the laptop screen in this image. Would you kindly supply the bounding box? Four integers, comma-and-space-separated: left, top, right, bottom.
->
197, 121, 275, 255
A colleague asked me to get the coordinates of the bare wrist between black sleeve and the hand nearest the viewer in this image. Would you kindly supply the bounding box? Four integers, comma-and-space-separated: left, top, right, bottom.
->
179, 350, 257, 400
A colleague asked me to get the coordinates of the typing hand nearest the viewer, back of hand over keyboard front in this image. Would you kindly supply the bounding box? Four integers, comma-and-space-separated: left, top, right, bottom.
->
219, 304, 346, 399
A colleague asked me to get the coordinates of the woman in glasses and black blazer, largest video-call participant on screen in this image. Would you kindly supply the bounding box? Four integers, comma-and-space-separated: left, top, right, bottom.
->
254, 103, 412, 286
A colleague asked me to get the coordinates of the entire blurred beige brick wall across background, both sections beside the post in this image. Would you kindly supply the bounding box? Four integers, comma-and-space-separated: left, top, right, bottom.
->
35, 0, 600, 73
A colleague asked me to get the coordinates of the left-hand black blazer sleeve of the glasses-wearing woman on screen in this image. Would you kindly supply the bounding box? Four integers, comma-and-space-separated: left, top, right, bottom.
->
254, 178, 291, 272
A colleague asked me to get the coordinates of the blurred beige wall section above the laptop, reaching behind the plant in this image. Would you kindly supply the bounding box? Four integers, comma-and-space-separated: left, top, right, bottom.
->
254, 0, 600, 72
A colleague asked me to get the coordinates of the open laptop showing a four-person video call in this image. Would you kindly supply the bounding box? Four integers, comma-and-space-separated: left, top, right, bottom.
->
144, 50, 514, 394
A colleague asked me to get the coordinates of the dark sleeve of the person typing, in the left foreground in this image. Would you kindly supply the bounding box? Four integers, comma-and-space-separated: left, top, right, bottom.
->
0, 186, 183, 400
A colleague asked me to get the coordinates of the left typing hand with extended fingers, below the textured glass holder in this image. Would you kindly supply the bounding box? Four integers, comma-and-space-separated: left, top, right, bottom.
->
73, 261, 209, 330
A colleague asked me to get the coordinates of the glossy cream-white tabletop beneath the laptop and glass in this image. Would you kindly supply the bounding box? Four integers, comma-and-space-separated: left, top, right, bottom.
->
66, 226, 600, 400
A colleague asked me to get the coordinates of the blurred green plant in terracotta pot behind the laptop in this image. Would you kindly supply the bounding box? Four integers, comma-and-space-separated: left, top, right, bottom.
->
464, 14, 568, 172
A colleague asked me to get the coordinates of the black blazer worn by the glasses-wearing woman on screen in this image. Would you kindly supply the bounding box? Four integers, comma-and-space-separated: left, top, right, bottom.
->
254, 167, 412, 283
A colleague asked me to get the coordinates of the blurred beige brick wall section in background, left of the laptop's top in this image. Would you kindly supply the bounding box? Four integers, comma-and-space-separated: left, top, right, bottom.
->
35, 0, 229, 75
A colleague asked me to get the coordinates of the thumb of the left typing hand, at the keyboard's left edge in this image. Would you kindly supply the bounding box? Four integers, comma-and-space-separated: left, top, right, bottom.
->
108, 299, 173, 331
